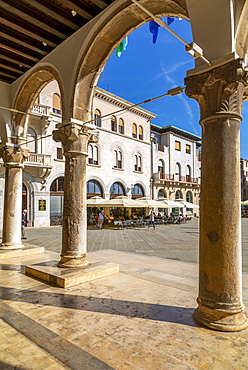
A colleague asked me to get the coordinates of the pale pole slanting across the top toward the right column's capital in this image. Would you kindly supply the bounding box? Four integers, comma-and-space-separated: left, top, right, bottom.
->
132, 0, 211, 66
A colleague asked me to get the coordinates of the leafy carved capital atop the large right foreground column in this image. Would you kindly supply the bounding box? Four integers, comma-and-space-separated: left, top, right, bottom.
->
185, 59, 248, 119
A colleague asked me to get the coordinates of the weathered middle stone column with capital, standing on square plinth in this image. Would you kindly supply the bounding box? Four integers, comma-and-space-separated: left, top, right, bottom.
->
53, 123, 98, 268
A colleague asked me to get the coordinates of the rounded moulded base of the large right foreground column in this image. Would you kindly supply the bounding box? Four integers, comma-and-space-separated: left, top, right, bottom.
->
194, 304, 248, 332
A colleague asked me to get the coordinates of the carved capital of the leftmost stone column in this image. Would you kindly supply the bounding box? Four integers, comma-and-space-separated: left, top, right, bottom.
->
0, 143, 29, 167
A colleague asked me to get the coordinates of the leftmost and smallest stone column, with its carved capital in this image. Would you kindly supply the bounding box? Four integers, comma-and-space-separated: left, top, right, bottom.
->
0, 144, 29, 249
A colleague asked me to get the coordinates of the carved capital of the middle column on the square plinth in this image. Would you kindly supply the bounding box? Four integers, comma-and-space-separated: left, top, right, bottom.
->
53, 122, 98, 156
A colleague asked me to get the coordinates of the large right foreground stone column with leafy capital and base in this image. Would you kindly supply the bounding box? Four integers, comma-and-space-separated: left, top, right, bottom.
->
185, 60, 247, 331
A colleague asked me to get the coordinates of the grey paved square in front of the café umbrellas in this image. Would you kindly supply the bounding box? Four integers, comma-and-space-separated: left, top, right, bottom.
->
23, 219, 248, 272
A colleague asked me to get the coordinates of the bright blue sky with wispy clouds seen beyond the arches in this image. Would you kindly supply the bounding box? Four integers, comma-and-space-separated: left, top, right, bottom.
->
98, 20, 248, 159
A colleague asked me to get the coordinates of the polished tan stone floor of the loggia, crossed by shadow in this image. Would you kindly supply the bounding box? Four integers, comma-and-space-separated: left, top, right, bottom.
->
0, 250, 248, 370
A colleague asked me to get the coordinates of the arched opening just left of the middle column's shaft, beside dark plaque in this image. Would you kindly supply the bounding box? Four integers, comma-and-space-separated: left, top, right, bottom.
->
50, 177, 64, 225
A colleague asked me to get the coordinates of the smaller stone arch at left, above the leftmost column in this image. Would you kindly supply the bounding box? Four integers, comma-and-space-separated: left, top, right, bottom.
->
12, 64, 65, 137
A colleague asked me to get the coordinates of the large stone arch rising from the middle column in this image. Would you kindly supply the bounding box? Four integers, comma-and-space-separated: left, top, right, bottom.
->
71, 0, 188, 121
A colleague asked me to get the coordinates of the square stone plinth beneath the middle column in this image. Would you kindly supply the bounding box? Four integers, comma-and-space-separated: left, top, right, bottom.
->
25, 261, 119, 288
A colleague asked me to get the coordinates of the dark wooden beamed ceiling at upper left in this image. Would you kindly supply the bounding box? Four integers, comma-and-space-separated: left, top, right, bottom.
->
0, 0, 114, 83
